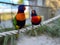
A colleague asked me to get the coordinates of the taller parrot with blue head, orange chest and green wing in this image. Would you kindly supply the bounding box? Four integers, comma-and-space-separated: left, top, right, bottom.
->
13, 4, 26, 38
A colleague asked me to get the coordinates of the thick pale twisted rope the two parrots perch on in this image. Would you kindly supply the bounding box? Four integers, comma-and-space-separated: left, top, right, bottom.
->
0, 15, 60, 37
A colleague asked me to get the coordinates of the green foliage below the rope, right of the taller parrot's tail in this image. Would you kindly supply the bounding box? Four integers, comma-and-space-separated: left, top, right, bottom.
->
25, 19, 60, 37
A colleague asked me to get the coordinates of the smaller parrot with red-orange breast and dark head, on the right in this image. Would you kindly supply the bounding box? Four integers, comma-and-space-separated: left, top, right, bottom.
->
31, 10, 41, 25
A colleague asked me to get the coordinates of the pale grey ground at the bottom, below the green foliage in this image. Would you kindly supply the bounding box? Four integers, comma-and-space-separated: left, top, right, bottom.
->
17, 35, 60, 45
